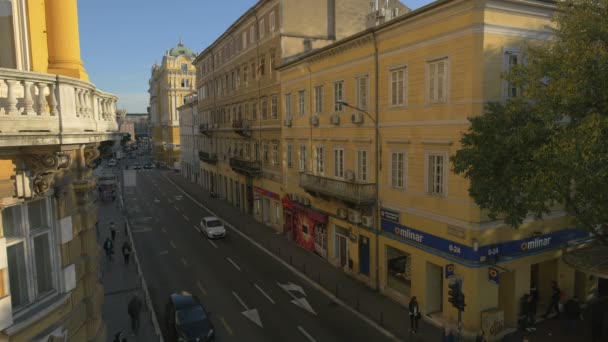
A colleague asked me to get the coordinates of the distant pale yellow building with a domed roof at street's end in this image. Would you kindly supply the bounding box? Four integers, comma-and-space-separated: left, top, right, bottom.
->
148, 40, 196, 167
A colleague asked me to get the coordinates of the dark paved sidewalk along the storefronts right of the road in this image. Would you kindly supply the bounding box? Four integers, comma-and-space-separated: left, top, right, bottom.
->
163, 172, 441, 341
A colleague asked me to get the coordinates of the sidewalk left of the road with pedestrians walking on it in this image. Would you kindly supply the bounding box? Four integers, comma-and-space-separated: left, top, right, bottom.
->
95, 167, 159, 342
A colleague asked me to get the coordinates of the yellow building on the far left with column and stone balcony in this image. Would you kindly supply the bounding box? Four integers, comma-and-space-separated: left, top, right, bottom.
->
0, 0, 120, 342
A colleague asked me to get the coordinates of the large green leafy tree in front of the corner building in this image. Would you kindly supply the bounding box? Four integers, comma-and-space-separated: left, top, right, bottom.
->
452, 0, 608, 242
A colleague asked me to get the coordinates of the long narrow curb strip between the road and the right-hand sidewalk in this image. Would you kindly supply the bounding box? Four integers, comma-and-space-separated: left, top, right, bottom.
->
161, 174, 400, 341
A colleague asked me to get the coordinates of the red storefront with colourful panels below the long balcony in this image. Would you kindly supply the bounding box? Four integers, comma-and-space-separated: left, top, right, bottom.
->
281, 195, 327, 258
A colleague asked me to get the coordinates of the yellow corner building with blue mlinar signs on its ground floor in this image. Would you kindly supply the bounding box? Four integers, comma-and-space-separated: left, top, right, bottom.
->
278, 0, 595, 338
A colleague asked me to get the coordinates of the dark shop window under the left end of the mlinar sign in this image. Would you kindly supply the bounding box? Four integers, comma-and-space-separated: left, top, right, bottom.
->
386, 246, 412, 296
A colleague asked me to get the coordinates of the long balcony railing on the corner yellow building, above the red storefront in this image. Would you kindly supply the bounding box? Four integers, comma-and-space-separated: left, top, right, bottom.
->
300, 172, 376, 205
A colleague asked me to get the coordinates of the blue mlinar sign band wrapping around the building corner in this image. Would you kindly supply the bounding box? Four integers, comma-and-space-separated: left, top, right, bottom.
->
381, 219, 588, 262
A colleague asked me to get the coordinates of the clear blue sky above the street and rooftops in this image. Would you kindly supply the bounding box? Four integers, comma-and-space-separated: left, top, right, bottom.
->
78, 0, 432, 113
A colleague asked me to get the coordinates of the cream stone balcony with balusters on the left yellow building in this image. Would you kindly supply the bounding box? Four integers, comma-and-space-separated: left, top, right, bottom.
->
0, 68, 119, 146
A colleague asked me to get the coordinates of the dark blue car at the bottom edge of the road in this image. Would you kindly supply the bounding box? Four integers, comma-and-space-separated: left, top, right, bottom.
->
167, 291, 215, 342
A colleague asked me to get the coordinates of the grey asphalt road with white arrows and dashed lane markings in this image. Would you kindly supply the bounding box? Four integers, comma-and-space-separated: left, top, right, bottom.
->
123, 158, 387, 341
